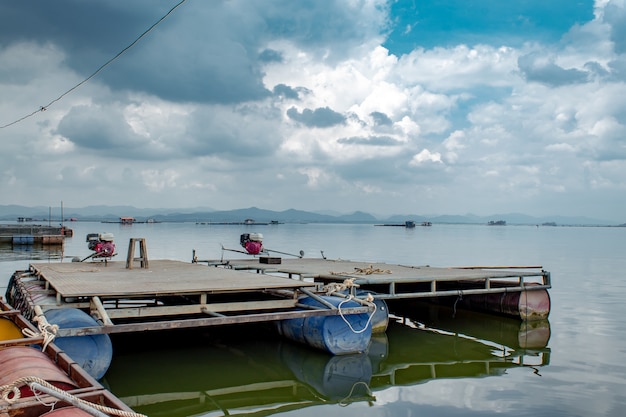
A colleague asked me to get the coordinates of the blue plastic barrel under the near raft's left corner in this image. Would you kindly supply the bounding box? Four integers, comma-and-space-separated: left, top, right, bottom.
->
45, 308, 113, 379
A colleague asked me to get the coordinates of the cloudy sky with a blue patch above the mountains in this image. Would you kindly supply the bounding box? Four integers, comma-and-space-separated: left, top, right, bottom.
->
0, 0, 626, 222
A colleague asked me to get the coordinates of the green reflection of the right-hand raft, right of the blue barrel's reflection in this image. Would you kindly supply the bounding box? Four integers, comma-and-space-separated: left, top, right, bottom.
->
371, 308, 550, 390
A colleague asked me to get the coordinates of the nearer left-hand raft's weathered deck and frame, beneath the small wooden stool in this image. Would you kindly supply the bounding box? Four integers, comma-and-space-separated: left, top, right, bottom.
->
7, 260, 374, 353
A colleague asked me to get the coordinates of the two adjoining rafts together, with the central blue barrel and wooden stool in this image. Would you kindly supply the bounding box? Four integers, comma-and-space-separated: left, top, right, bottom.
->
6, 255, 551, 377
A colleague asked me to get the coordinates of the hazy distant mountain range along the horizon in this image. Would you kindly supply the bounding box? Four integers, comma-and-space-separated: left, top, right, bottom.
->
0, 205, 626, 226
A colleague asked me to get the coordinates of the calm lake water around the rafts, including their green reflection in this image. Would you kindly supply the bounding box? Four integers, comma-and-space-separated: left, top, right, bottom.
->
0, 219, 626, 417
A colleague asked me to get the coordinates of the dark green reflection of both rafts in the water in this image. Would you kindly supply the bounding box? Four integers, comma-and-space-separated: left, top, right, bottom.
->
104, 308, 550, 417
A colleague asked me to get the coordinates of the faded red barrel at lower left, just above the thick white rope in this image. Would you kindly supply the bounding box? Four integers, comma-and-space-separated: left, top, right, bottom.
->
0, 346, 78, 397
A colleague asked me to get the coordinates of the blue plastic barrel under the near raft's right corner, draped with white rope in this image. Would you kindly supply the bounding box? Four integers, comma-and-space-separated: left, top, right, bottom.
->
279, 296, 372, 355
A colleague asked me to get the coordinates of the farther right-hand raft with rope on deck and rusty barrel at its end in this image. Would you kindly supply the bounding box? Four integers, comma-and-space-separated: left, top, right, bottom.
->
217, 258, 552, 320
